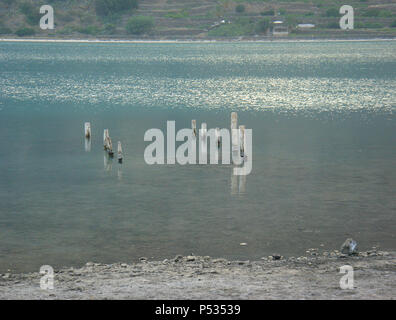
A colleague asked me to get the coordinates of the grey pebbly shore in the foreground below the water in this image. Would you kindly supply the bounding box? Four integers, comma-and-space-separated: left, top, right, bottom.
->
0, 249, 396, 300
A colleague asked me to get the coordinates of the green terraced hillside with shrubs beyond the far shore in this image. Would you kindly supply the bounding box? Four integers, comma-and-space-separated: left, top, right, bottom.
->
0, 0, 396, 39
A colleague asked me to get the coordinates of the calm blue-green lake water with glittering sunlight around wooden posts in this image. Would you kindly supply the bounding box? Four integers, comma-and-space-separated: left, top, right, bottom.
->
0, 41, 396, 272
